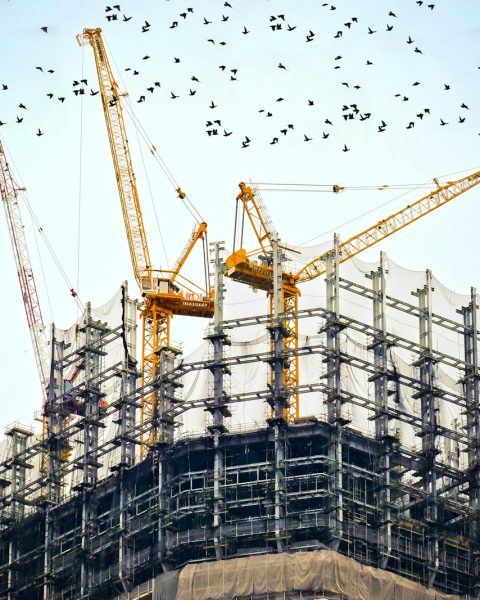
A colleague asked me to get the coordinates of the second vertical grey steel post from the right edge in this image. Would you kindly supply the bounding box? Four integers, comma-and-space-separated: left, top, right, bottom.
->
413, 270, 439, 586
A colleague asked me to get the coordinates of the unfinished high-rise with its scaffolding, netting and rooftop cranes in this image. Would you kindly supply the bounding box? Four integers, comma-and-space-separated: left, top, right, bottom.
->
0, 29, 480, 600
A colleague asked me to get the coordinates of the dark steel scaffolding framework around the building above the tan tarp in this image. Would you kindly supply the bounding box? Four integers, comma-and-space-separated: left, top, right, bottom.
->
0, 250, 480, 600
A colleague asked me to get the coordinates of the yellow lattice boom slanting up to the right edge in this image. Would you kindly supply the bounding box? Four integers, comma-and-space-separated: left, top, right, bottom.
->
294, 171, 480, 284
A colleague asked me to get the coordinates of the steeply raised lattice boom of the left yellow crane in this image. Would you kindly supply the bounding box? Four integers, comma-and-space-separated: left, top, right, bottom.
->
77, 28, 152, 289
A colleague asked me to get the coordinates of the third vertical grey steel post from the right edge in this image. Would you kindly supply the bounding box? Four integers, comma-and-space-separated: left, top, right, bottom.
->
369, 252, 394, 569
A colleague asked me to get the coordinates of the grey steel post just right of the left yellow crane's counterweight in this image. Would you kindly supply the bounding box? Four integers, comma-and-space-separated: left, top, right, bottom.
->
207, 242, 231, 560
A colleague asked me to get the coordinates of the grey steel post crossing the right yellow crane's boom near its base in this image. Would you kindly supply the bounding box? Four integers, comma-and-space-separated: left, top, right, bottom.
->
323, 235, 349, 550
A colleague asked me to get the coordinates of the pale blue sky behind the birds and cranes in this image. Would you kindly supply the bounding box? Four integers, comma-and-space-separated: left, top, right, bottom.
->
0, 0, 480, 427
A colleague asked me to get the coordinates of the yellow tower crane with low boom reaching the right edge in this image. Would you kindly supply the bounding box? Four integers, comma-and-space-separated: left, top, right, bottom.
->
226, 171, 480, 422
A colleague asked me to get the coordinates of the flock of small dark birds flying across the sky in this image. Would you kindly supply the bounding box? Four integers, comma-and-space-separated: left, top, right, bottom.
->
0, 0, 480, 152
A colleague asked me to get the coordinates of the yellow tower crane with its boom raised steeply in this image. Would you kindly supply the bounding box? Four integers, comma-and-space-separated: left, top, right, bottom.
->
77, 28, 214, 445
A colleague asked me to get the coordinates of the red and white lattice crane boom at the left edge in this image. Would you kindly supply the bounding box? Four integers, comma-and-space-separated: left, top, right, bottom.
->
0, 142, 50, 401
